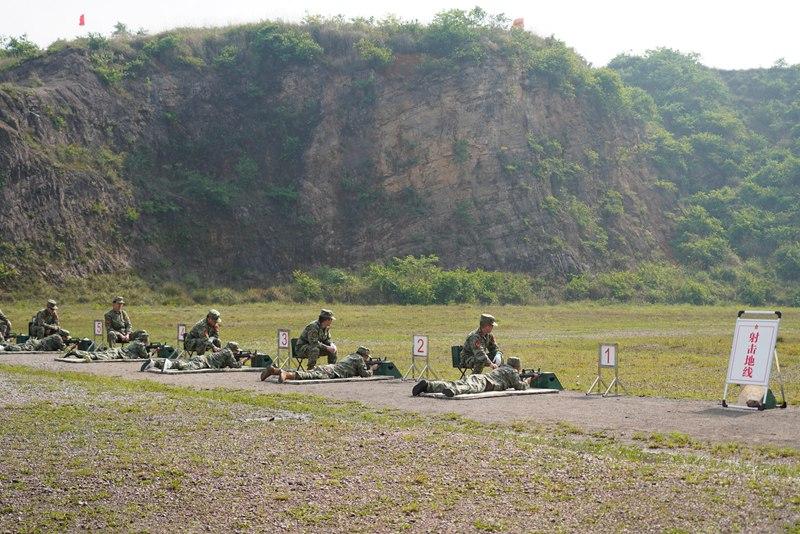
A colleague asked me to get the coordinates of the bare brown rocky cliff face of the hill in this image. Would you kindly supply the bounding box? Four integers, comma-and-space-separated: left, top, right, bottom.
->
0, 28, 669, 284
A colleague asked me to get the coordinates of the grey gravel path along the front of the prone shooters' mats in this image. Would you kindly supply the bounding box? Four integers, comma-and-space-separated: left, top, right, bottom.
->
0, 354, 800, 448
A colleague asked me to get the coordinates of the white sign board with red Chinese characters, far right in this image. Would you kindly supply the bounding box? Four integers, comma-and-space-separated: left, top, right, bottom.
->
728, 319, 778, 386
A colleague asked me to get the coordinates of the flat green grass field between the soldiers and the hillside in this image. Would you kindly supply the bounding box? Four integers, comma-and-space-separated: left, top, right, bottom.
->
4, 304, 800, 405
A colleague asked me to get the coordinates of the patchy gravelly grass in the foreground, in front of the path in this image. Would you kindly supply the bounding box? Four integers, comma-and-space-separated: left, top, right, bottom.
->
0, 364, 800, 532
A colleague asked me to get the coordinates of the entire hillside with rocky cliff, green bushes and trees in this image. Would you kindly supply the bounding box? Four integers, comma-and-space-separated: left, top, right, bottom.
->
0, 8, 800, 304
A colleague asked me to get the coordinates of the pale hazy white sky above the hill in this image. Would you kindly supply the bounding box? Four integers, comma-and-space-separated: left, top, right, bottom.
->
0, 0, 800, 69
